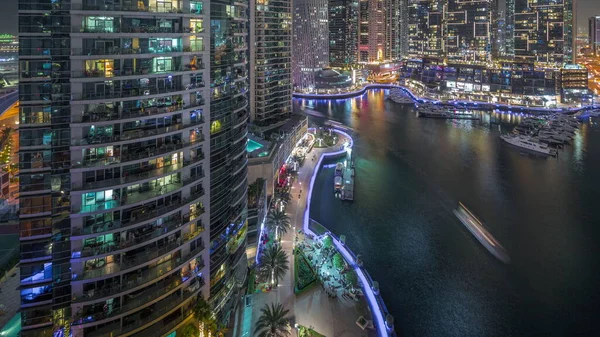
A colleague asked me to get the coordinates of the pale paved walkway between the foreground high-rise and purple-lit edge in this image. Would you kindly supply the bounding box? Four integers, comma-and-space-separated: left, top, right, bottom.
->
236, 131, 374, 337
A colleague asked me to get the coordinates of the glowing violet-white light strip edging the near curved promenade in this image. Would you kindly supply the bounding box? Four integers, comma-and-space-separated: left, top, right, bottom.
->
303, 129, 391, 337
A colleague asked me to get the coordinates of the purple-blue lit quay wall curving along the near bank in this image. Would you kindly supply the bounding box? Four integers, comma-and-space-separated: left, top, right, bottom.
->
303, 128, 397, 337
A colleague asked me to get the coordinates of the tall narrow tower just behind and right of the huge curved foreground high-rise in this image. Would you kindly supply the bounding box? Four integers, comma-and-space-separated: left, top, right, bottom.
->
250, 0, 292, 126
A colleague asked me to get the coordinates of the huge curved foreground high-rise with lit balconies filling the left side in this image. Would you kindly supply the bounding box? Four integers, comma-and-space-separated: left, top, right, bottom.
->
19, 0, 248, 337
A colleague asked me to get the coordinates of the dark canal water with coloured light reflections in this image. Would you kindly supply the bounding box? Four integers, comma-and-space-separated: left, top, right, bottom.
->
294, 90, 600, 337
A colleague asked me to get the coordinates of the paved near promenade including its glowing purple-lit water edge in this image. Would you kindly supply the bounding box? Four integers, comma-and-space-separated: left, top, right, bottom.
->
234, 128, 393, 337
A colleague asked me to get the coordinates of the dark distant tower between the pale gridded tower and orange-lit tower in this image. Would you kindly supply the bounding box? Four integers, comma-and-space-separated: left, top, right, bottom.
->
328, 0, 359, 67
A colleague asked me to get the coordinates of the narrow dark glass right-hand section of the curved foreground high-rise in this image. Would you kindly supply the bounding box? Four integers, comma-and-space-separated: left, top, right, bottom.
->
209, 0, 249, 321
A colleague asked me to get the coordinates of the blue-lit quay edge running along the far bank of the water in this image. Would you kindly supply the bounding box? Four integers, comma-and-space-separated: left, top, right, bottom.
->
292, 84, 600, 115
